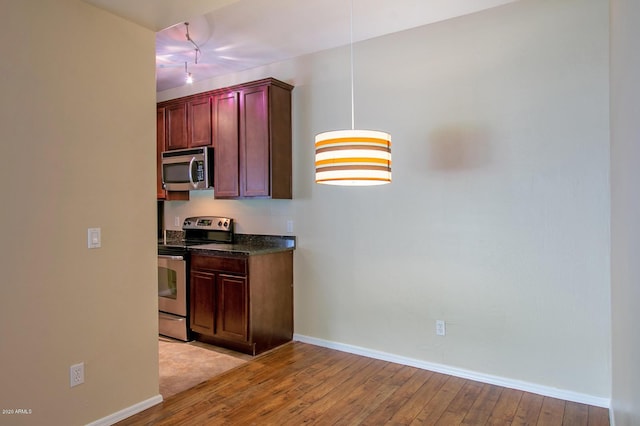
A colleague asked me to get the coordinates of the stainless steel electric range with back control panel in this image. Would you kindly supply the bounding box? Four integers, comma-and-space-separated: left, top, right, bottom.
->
158, 216, 234, 341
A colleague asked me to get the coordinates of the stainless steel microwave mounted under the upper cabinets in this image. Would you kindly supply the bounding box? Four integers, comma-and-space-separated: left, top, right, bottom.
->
162, 147, 213, 191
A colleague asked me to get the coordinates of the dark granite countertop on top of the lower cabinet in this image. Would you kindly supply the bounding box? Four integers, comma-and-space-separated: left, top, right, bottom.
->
189, 234, 296, 256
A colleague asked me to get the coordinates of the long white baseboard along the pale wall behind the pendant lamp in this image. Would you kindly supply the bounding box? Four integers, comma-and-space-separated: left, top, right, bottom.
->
293, 334, 611, 408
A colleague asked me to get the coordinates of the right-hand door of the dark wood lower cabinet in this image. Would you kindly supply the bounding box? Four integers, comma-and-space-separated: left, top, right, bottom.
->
216, 274, 249, 342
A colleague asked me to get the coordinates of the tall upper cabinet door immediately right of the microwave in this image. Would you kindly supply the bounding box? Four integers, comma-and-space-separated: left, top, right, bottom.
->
213, 91, 240, 198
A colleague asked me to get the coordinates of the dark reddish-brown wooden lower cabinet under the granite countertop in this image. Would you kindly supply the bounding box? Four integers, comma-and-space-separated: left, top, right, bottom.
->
190, 251, 293, 355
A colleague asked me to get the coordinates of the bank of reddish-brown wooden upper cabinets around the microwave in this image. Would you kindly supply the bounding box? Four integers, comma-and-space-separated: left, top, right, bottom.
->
158, 78, 293, 199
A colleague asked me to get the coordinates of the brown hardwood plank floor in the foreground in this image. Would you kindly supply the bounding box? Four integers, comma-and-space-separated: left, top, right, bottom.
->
118, 342, 609, 426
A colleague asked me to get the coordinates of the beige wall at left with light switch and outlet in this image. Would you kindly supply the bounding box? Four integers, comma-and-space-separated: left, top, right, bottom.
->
0, 0, 158, 425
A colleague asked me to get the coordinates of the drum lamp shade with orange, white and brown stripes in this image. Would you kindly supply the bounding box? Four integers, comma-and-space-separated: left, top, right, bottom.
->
316, 130, 391, 186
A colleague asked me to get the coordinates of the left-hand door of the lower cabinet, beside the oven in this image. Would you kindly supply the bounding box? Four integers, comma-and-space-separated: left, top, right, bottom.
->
191, 270, 216, 336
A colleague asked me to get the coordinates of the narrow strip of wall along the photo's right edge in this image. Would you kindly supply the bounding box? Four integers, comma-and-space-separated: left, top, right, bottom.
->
611, 0, 640, 426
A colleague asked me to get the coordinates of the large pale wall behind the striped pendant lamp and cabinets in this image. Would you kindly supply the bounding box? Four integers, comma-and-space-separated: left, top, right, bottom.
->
159, 0, 611, 401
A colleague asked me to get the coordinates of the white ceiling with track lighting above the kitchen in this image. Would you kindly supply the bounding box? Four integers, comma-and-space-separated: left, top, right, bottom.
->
85, 0, 517, 92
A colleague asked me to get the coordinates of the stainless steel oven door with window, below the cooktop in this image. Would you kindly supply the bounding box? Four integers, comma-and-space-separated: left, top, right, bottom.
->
158, 255, 187, 317
